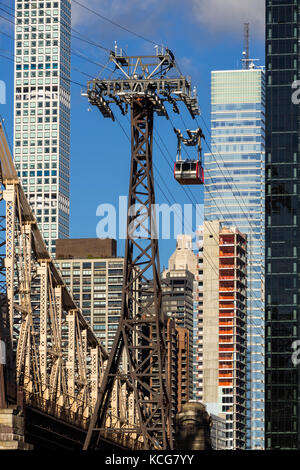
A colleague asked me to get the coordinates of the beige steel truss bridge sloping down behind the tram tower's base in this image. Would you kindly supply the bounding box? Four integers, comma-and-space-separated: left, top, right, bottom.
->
0, 124, 143, 449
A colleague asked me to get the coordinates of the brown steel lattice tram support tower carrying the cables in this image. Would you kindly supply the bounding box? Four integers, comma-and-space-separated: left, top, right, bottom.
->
84, 46, 200, 450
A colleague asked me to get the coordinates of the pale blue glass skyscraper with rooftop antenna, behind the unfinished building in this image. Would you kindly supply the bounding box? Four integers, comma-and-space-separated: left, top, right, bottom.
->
204, 64, 265, 449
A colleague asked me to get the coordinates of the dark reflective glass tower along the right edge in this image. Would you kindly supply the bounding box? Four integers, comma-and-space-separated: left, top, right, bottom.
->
266, 0, 300, 449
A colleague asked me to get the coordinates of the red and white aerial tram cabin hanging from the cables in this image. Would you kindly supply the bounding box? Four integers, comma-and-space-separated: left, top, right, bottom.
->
174, 128, 205, 185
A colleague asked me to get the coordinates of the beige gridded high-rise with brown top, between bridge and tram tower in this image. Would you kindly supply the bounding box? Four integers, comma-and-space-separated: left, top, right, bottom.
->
55, 239, 124, 351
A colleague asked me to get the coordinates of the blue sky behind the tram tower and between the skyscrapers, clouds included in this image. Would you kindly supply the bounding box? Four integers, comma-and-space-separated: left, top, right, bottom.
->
0, 0, 265, 265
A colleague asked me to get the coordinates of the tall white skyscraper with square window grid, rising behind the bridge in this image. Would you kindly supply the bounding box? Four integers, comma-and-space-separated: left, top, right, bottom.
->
14, 0, 71, 255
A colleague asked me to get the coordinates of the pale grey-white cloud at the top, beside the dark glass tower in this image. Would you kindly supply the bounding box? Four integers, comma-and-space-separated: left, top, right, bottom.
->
189, 0, 265, 36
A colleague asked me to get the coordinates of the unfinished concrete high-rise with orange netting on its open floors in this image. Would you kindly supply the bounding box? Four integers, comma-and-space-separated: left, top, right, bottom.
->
199, 221, 247, 450
